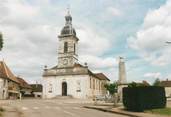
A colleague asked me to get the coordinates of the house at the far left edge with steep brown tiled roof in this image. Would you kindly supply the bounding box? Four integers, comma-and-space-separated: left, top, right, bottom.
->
0, 61, 20, 99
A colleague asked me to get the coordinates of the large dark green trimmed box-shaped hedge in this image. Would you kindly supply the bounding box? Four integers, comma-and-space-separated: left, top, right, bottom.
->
123, 86, 166, 111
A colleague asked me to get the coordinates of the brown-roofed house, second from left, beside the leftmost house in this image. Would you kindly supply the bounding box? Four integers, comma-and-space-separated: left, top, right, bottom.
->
17, 77, 32, 97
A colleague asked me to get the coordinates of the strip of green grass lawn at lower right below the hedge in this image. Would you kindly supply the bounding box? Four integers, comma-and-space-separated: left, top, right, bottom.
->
145, 108, 171, 115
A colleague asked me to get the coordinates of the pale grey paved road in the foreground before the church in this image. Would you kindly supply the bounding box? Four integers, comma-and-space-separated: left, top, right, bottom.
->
3, 99, 126, 117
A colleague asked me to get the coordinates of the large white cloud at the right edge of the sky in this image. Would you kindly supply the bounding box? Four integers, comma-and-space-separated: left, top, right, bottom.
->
127, 0, 171, 66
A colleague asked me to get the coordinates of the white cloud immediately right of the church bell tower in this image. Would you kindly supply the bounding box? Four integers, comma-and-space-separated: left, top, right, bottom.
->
76, 25, 111, 55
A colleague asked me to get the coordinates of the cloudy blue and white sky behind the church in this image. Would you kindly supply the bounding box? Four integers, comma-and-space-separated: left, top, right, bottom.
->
0, 0, 171, 83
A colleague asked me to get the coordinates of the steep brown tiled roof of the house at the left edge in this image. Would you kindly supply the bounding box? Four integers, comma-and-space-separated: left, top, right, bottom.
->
0, 61, 19, 83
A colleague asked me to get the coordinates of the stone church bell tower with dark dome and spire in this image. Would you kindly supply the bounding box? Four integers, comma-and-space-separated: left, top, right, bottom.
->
58, 10, 79, 68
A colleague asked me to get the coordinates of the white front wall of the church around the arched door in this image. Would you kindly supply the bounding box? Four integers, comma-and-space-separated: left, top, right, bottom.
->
43, 75, 90, 98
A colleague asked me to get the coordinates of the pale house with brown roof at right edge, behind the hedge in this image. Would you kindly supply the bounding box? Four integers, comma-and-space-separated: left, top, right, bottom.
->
160, 79, 171, 98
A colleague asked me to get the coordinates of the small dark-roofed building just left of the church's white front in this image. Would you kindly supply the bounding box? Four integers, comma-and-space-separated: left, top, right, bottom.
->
30, 84, 43, 98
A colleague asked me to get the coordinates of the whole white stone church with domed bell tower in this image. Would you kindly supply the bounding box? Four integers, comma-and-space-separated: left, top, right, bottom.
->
43, 12, 110, 99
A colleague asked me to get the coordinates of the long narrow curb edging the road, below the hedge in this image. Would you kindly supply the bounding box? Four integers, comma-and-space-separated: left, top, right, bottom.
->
84, 106, 141, 117
